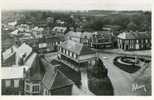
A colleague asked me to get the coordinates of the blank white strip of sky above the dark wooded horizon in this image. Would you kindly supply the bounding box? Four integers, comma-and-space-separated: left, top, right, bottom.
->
1, 0, 152, 10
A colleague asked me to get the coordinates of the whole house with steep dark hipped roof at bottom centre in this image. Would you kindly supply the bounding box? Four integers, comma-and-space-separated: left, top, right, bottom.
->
42, 66, 73, 95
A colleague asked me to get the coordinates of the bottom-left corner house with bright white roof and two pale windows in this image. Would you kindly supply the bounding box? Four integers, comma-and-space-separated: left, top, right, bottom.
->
1, 66, 24, 95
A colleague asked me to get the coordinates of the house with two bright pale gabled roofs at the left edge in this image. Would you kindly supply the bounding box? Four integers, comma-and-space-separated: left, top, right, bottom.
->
2, 43, 33, 67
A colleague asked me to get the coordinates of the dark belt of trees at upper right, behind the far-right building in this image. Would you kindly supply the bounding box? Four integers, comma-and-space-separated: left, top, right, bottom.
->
83, 12, 151, 31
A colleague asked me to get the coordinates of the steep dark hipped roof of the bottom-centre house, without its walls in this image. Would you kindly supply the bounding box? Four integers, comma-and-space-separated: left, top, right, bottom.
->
42, 67, 73, 90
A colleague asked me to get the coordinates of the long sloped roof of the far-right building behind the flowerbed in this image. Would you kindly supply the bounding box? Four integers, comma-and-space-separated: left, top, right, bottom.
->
118, 32, 151, 39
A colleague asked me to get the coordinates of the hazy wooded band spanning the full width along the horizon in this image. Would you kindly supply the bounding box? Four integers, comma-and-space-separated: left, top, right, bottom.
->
2, 10, 151, 31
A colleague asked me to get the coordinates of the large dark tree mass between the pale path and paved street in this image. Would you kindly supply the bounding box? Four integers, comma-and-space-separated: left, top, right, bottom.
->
88, 58, 113, 95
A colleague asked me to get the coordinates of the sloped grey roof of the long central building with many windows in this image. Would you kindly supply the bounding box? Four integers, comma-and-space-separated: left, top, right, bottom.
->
61, 40, 95, 55
